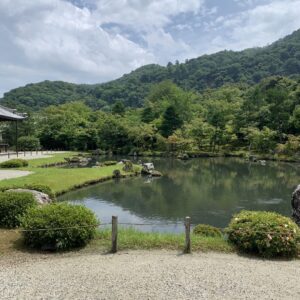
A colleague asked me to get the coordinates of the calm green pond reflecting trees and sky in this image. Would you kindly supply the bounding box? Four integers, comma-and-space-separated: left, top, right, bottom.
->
59, 158, 300, 232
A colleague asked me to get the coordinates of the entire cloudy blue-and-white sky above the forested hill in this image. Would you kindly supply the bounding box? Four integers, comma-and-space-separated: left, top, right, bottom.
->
0, 0, 300, 96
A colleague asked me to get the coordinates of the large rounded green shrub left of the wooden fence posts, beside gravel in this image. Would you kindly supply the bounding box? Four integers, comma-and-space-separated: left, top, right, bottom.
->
21, 203, 98, 250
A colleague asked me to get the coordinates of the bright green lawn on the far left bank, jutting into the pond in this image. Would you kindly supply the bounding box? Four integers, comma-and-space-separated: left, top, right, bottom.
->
0, 152, 135, 194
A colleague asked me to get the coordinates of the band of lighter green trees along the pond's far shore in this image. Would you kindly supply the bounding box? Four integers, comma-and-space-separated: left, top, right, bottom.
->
3, 76, 300, 155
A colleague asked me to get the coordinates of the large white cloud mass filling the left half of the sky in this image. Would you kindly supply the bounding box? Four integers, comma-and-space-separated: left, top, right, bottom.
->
0, 0, 155, 92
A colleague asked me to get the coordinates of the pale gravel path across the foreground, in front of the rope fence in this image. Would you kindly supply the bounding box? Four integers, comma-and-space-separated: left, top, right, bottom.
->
0, 251, 300, 300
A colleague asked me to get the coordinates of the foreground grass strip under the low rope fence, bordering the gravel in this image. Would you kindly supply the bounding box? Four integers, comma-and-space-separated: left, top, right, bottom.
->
0, 228, 235, 257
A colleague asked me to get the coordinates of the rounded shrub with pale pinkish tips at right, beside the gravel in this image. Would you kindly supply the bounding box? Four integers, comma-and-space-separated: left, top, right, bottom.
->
226, 211, 300, 258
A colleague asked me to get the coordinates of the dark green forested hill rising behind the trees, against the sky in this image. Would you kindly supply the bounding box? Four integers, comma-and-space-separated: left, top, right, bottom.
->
1, 30, 300, 110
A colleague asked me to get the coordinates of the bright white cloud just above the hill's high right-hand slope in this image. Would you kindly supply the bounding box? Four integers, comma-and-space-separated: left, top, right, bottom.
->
212, 0, 300, 50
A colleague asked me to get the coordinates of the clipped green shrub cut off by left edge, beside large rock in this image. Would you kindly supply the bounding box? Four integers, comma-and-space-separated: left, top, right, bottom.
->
0, 192, 37, 228
